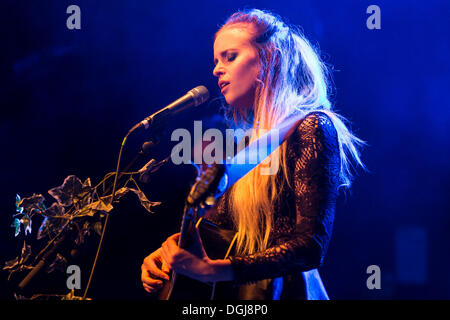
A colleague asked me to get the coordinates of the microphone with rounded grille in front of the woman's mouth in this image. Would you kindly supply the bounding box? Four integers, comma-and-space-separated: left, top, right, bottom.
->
130, 86, 209, 132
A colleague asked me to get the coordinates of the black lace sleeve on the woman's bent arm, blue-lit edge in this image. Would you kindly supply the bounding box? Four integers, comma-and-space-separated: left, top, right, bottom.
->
229, 112, 340, 284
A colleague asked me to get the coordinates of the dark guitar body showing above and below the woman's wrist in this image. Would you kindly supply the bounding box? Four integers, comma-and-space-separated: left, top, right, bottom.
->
159, 219, 237, 300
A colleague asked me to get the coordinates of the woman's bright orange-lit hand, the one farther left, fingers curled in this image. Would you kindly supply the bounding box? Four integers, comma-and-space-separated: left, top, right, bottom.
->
141, 248, 170, 293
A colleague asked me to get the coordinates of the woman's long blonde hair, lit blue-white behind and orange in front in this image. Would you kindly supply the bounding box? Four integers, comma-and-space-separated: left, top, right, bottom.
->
216, 9, 364, 254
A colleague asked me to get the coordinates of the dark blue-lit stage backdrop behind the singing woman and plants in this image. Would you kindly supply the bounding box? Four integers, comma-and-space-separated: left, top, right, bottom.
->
0, 0, 450, 299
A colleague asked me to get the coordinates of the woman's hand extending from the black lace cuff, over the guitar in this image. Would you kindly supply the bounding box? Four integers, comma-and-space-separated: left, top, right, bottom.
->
161, 229, 233, 282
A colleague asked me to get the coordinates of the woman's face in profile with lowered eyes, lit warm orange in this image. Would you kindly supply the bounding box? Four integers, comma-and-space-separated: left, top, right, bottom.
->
213, 25, 260, 112
